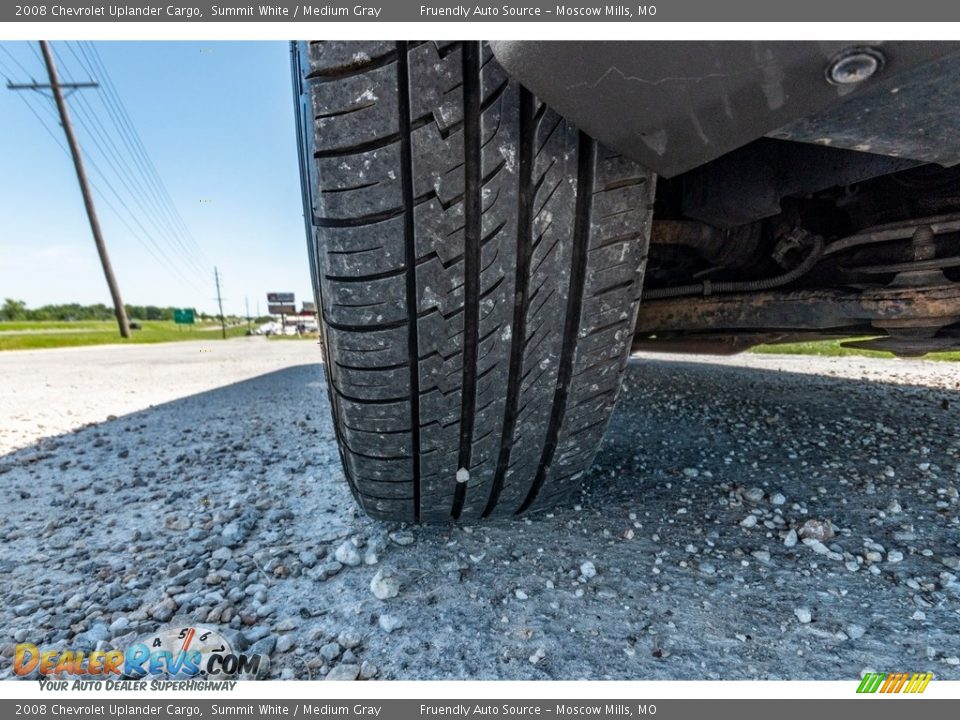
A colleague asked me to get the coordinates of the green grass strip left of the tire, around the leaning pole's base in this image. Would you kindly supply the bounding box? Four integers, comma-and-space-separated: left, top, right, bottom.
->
0, 320, 247, 351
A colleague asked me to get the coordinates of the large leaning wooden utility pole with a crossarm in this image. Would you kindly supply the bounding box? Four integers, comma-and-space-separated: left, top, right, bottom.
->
7, 40, 130, 338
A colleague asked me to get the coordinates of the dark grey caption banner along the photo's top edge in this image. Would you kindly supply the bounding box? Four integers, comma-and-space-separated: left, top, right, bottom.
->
0, 0, 960, 23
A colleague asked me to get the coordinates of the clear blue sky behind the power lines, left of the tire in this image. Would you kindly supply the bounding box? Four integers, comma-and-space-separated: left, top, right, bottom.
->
0, 42, 312, 314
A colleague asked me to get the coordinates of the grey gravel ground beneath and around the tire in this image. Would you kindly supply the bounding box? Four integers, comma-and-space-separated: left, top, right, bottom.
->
0, 339, 960, 679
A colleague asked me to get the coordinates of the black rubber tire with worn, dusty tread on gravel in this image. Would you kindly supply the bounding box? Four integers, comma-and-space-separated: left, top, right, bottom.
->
294, 42, 655, 522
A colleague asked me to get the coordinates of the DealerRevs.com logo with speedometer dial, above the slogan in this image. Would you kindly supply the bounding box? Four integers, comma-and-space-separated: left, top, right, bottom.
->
13, 626, 269, 680
